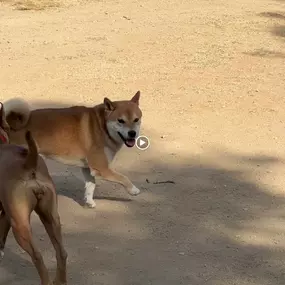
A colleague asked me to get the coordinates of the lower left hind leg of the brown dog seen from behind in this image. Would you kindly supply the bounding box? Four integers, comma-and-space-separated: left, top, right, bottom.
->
11, 219, 50, 285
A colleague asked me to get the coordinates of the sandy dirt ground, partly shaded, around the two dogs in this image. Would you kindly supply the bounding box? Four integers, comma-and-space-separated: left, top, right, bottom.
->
0, 0, 285, 285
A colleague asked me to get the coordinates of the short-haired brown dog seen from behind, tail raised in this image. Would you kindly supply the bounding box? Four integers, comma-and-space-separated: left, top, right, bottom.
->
0, 103, 67, 285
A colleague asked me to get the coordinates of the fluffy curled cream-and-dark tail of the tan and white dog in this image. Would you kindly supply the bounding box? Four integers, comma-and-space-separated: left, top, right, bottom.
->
3, 98, 31, 130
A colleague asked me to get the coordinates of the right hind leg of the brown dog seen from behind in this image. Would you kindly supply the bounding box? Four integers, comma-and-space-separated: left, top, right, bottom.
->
35, 192, 67, 285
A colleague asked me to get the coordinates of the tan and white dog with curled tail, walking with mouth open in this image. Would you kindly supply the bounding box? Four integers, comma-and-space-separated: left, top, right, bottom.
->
4, 91, 142, 208
